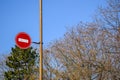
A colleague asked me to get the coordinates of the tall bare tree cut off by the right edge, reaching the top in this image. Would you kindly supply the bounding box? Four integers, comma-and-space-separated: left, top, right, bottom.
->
96, 0, 120, 80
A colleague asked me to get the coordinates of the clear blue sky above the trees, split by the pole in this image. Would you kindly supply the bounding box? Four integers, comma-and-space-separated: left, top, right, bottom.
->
0, 0, 105, 54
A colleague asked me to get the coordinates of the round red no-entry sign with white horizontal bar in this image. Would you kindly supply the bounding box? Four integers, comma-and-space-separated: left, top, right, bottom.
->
15, 32, 31, 49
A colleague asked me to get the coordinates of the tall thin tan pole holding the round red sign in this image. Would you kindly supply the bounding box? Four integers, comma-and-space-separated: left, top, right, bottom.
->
39, 0, 43, 80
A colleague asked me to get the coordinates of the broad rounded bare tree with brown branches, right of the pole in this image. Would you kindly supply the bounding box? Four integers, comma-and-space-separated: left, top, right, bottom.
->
44, 23, 118, 80
